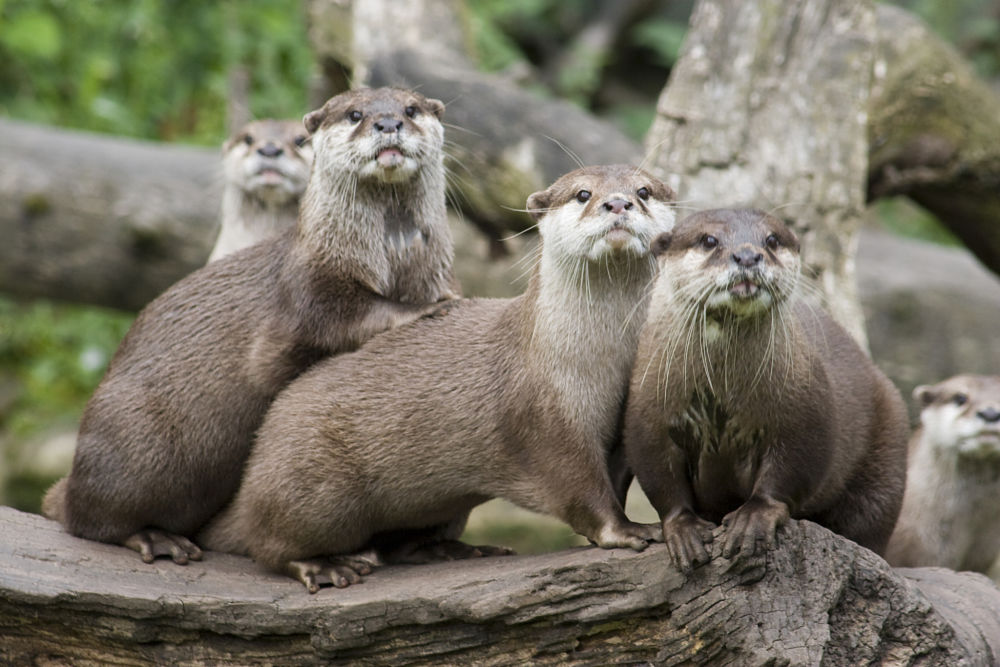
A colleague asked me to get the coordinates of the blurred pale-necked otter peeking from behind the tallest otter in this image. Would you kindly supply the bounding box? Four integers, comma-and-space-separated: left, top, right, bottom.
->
208, 119, 313, 262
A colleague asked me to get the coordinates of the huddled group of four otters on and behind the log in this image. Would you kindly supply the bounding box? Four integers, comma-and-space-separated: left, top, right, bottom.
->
43, 88, 1000, 592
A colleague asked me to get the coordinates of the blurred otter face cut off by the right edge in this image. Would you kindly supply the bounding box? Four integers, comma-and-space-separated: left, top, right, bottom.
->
913, 375, 1000, 460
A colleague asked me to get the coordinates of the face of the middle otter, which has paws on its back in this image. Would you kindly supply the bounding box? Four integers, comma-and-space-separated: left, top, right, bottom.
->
528, 165, 675, 262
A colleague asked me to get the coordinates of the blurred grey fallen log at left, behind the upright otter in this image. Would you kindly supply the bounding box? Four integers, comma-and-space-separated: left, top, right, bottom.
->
0, 120, 222, 310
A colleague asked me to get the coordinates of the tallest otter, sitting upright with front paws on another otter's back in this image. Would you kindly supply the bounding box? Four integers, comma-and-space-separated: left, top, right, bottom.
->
43, 89, 456, 564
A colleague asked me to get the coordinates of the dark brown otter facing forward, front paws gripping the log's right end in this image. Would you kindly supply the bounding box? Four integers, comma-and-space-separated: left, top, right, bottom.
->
623, 209, 908, 571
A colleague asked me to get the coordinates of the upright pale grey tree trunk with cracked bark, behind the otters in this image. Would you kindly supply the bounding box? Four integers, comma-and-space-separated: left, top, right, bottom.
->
646, 0, 876, 345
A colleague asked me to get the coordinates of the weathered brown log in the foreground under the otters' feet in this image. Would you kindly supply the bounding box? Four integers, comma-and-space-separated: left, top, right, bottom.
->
0, 508, 1000, 666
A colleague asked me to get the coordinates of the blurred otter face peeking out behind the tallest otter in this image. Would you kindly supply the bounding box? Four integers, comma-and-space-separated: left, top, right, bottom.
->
222, 120, 313, 206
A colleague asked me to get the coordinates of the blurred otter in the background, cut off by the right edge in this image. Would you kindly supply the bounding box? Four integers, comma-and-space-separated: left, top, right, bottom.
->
886, 375, 1000, 577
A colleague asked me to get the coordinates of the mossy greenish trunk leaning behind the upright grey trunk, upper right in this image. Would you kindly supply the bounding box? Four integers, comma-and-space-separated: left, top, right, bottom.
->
868, 5, 1000, 273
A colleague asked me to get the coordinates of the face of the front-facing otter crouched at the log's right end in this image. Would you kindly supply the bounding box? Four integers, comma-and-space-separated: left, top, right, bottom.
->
654, 209, 800, 318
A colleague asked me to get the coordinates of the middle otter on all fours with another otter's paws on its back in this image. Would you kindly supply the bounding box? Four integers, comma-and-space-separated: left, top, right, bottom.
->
200, 165, 674, 592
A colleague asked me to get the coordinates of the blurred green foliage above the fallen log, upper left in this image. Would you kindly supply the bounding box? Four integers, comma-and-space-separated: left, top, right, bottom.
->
0, 0, 312, 144
